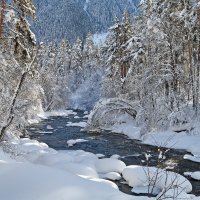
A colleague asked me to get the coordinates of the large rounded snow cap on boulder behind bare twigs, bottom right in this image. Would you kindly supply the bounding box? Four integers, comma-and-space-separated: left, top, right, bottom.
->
122, 165, 192, 193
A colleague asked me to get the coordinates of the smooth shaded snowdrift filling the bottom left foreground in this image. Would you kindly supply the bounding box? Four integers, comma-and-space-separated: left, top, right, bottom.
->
0, 163, 134, 200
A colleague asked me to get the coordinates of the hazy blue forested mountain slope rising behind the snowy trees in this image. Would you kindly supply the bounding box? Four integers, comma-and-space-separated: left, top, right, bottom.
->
32, 0, 138, 42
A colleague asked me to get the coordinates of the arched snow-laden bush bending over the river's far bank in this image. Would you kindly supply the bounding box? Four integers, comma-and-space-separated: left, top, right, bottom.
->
86, 98, 137, 130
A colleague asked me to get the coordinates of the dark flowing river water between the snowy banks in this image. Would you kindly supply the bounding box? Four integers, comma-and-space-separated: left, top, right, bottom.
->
27, 110, 200, 196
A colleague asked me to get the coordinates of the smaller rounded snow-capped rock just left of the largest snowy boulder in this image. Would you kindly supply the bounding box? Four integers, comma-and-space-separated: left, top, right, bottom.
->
95, 158, 126, 173
